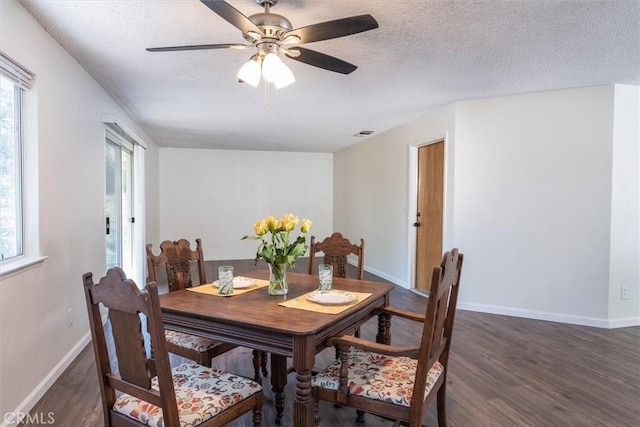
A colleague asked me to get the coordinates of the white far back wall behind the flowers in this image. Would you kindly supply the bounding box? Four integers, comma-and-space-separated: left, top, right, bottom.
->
158, 148, 333, 260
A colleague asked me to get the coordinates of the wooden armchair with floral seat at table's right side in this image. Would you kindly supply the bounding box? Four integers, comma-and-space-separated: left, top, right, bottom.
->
311, 249, 463, 427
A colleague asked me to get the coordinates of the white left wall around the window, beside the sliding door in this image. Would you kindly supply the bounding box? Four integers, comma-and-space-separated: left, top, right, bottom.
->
0, 0, 157, 421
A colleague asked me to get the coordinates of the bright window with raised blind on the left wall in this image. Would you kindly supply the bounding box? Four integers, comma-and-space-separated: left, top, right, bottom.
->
0, 52, 33, 260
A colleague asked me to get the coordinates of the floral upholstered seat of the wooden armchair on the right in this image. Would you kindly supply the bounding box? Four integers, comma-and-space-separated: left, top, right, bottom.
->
312, 348, 444, 407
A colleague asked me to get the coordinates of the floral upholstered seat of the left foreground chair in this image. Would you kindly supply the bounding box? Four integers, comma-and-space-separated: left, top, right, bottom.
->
113, 363, 262, 427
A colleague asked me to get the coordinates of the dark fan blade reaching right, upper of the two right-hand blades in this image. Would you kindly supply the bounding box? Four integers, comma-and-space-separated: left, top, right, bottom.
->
282, 15, 378, 44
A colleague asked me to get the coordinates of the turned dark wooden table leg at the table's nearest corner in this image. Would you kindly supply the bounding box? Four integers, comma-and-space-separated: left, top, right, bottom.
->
293, 336, 315, 427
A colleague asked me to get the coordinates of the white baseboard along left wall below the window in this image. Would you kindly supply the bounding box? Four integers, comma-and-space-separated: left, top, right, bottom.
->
1, 332, 91, 427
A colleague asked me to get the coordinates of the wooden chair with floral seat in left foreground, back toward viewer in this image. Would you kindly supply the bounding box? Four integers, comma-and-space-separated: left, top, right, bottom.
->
82, 267, 264, 427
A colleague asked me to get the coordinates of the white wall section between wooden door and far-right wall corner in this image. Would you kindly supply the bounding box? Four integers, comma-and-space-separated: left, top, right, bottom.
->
454, 86, 613, 323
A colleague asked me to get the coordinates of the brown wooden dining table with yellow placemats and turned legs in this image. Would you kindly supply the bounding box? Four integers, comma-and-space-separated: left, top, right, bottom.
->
160, 270, 393, 426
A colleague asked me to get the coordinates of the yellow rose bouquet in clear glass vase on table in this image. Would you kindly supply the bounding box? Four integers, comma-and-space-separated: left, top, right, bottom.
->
242, 213, 312, 295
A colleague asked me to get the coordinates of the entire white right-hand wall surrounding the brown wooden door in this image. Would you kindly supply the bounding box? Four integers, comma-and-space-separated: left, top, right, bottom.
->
334, 86, 640, 327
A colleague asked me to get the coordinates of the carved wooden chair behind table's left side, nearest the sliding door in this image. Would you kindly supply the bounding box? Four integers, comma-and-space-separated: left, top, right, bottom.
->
147, 238, 268, 381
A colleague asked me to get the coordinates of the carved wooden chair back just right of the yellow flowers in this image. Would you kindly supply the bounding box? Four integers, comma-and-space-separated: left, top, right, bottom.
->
309, 232, 364, 280
